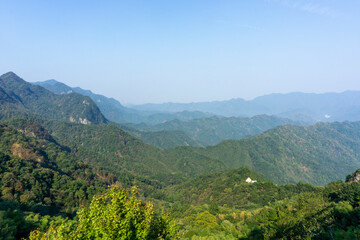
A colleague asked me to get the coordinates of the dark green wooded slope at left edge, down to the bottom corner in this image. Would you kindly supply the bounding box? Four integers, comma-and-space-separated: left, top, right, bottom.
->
0, 122, 110, 239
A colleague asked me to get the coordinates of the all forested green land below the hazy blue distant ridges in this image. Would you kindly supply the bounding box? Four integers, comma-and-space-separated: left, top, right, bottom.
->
0, 73, 360, 239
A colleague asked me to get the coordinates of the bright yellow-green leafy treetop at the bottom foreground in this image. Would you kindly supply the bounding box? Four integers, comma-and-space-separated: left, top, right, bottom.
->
30, 188, 176, 240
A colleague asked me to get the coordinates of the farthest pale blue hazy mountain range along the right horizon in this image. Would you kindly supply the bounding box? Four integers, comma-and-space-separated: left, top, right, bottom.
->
132, 91, 360, 122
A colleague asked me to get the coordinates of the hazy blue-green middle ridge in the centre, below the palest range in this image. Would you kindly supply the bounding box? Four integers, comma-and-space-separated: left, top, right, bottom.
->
128, 115, 303, 146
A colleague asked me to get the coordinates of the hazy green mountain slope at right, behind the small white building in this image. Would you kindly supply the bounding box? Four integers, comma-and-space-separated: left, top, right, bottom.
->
198, 122, 360, 185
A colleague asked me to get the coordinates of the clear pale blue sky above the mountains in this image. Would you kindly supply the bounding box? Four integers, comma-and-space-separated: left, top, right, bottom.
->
0, 0, 360, 104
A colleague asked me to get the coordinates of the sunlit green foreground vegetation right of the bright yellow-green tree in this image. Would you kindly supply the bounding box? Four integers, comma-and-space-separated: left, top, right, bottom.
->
174, 183, 360, 240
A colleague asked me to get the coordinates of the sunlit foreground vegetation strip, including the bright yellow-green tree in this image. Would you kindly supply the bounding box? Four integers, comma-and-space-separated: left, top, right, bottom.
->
13, 172, 360, 239
